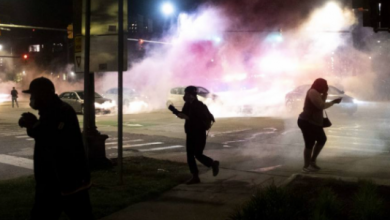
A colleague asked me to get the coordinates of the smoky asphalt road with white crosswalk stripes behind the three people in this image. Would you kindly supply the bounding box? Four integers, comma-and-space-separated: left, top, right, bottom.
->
0, 102, 390, 179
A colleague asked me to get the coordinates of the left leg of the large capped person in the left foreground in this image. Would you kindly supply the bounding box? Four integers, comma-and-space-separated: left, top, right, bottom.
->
30, 187, 62, 220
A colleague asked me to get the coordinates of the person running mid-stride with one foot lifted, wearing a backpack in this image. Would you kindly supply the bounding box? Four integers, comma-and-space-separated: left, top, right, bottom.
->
169, 86, 219, 184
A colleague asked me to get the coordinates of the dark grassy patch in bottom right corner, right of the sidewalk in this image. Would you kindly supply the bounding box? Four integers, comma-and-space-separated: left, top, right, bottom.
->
229, 177, 390, 220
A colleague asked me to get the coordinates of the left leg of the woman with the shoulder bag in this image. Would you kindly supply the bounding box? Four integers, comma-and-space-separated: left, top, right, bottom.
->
298, 120, 315, 168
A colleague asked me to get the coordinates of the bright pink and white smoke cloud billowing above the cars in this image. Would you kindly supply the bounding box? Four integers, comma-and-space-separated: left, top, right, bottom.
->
93, 1, 375, 117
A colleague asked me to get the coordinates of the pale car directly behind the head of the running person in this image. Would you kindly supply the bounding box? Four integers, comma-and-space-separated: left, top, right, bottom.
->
166, 86, 219, 108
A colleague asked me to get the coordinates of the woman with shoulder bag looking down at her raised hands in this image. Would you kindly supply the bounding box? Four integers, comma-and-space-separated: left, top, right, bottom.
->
298, 78, 341, 172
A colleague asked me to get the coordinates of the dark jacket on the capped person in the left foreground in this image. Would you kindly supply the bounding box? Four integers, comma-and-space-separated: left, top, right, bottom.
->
27, 95, 90, 194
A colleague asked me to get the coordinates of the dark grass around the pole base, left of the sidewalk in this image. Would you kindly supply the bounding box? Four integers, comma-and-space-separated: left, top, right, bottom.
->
0, 157, 188, 220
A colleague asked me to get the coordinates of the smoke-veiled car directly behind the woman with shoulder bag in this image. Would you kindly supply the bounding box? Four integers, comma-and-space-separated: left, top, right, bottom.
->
285, 85, 358, 115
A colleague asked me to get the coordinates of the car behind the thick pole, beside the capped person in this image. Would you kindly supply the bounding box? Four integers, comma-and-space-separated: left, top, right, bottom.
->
59, 91, 116, 113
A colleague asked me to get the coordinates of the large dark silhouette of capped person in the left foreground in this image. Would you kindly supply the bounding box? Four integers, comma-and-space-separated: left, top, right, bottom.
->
19, 77, 93, 220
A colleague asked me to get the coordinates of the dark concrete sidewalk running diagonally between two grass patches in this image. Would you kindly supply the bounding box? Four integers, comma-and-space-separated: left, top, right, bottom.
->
102, 169, 287, 220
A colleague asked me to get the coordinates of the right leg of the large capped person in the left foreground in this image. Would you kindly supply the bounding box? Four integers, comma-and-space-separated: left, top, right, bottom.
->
62, 190, 94, 220
